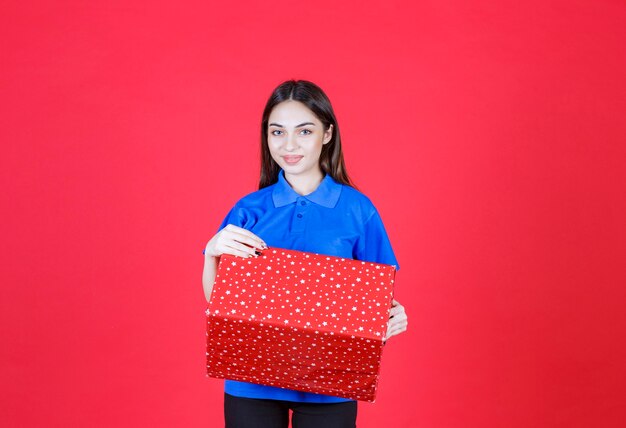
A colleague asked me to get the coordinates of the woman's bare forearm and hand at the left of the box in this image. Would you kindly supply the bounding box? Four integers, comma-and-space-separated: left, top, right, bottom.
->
202, 224, 267, 302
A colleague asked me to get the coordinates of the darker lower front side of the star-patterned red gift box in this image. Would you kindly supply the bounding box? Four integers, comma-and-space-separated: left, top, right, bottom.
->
207, 316, 382, 401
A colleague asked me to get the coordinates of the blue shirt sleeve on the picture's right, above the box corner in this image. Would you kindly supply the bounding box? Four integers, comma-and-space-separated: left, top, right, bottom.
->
354, 210, 400, 270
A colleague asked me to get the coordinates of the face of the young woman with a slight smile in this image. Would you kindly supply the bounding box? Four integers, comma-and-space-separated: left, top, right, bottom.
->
267, 100, 333, 179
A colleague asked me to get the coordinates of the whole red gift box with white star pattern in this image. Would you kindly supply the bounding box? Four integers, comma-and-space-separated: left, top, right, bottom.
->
206, 248, 396, 402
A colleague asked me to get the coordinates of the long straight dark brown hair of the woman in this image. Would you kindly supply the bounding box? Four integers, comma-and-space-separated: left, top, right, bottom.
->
259, 80, 356, 189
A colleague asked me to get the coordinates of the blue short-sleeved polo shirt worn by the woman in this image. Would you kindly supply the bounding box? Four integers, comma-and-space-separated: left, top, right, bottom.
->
206, 170, 400, 403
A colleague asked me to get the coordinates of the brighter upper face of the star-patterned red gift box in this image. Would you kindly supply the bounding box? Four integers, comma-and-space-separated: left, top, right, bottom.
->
207, 248, 396, 341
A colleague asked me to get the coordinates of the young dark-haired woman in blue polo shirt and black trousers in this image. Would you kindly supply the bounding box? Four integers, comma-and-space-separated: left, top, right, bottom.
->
202, 80, 407, 428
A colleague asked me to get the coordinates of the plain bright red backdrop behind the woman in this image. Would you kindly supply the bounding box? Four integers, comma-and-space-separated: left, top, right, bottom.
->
0, 0, 626, 428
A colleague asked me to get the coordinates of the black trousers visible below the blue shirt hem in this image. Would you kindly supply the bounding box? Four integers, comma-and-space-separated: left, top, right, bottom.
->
224, 393, 357, 428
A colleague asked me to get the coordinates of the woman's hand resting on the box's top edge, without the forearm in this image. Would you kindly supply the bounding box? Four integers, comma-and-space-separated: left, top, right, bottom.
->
204, 224, 267, 257
